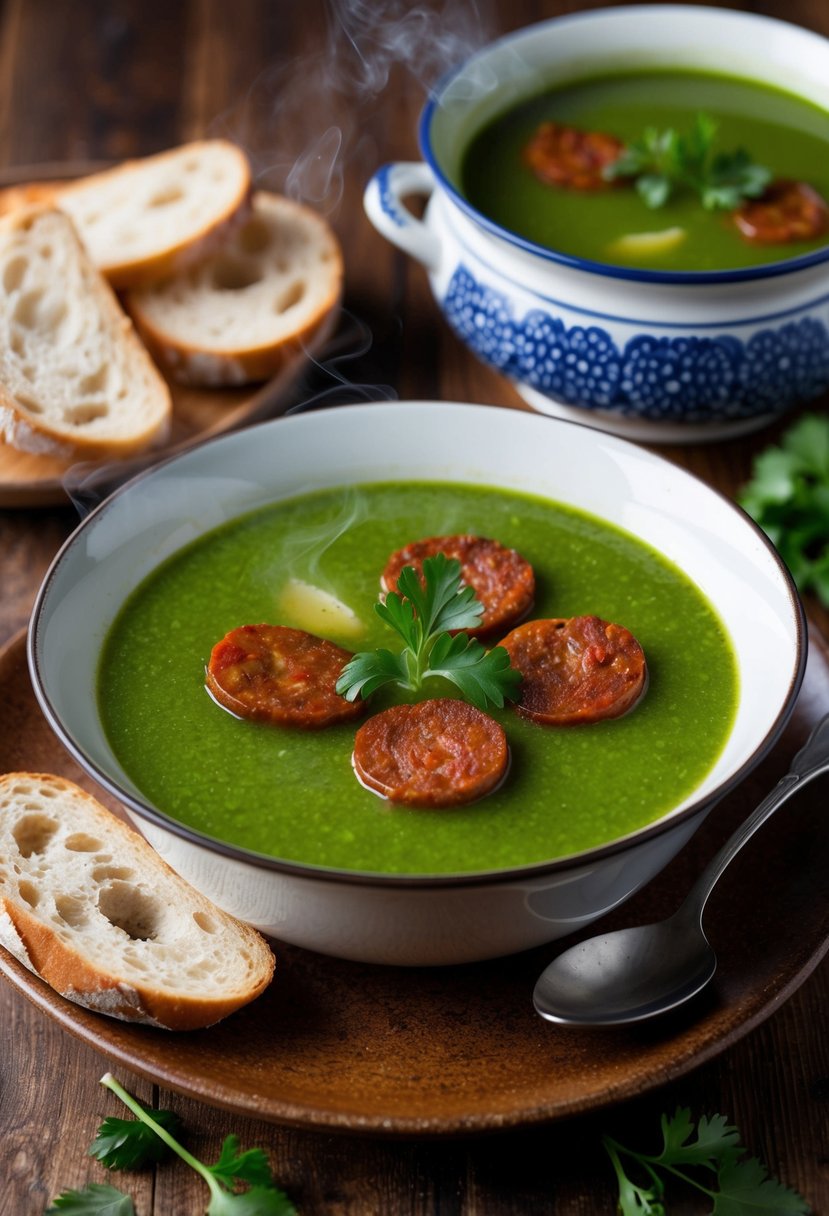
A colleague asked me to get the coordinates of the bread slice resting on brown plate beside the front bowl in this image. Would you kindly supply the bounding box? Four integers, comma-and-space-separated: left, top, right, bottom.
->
0, 772, 273, 1030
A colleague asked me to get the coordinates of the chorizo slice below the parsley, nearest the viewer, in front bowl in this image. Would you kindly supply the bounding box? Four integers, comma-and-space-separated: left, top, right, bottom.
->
354, 697, 509, 806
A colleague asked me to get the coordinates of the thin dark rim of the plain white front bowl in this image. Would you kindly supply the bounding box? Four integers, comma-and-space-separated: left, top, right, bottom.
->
26, 400, 808, 890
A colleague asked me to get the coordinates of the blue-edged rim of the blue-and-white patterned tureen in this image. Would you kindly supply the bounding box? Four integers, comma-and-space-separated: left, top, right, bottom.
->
418, 4, 829, 285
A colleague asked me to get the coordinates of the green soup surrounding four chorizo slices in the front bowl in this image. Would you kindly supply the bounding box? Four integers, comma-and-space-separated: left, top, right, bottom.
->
100, 483, 737, 874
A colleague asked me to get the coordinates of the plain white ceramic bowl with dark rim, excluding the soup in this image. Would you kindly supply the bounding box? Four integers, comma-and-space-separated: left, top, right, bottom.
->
29, 402, 806, 964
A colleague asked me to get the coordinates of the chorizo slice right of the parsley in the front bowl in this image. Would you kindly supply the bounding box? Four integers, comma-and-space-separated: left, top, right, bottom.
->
501, 617, 647, 726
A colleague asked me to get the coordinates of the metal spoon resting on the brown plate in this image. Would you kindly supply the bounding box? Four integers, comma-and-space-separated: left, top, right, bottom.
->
532, 715, 829, 1026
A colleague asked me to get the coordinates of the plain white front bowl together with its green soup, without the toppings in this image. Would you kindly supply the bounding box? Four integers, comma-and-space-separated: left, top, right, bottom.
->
29, 402, 806, 964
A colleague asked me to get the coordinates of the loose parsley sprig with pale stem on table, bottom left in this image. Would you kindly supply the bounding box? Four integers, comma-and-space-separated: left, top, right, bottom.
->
46, 1073, 297, 1216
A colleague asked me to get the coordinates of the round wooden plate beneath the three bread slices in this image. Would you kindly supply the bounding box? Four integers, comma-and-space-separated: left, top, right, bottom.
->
0, 162, 337, 507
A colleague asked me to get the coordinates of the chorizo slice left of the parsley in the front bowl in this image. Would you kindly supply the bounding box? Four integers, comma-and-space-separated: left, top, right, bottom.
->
207, 625, 366, 730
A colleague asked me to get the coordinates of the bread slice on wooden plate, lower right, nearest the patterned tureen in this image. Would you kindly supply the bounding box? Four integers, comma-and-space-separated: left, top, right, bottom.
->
124, 191, 343, 387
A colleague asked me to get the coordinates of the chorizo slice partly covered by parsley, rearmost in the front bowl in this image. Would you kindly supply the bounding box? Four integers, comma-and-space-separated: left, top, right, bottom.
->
380, 535, 535, 637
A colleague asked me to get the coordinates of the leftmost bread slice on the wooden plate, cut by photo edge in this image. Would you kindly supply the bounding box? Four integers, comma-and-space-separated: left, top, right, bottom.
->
0, 207, 171, 458
